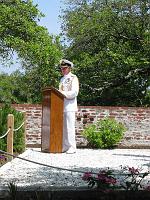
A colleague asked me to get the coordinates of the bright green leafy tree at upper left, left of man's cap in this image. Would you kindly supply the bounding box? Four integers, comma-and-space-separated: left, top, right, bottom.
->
0, 0, 62, 102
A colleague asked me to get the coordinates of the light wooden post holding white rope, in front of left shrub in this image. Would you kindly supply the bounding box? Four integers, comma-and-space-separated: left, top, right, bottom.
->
7, 114, 14, 161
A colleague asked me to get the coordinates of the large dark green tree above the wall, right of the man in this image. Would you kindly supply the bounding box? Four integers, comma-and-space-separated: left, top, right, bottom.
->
62, 0, 150, 106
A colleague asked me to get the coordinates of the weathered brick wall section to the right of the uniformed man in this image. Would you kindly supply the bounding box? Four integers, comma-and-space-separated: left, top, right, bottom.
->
76, 106, 150, 148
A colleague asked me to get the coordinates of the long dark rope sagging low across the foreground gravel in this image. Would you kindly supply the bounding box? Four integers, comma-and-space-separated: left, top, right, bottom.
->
0, 150, 150, 176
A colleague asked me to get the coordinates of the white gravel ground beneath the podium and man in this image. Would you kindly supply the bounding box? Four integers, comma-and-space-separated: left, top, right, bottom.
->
0, 149, 150, 190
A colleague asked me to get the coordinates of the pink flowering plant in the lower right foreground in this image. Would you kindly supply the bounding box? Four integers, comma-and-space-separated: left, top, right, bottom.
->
82, 167, 150, 191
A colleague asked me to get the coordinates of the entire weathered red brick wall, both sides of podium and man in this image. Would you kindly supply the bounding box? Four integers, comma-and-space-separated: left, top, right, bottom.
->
12, 104, 150, 148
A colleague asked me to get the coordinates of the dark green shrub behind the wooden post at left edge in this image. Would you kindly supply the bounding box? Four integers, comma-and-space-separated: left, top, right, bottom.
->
0, 105, 25, 153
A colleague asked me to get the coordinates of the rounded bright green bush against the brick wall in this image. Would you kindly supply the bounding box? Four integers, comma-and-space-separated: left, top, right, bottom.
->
82, 118, 126, 149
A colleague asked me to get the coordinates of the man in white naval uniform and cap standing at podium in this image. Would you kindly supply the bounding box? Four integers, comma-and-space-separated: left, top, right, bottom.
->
59, 59, 79, 153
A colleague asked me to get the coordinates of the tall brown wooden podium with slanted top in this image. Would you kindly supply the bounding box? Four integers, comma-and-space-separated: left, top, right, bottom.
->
41, 87, 65, 153
